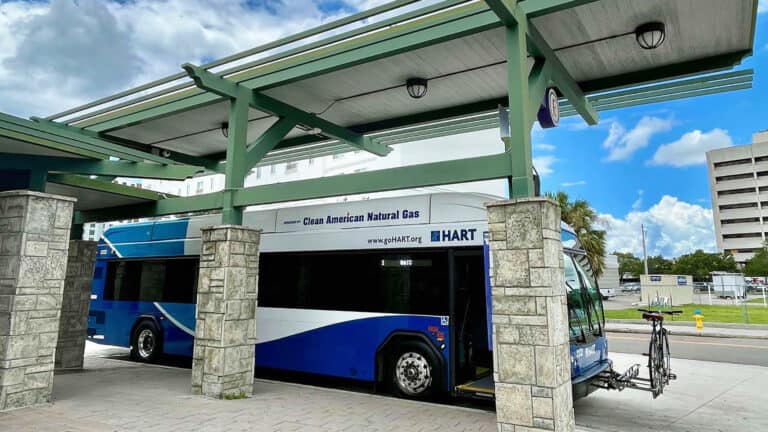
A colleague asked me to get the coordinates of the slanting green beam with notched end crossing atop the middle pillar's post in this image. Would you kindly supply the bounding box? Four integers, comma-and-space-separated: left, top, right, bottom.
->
182, 63, 392, 156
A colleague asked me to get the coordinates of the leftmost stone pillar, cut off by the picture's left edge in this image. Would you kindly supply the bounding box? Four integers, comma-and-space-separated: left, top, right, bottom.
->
0, 191, 75, 411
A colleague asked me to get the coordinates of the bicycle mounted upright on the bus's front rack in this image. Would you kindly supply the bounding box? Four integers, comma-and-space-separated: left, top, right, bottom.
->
638, 309, 683, 399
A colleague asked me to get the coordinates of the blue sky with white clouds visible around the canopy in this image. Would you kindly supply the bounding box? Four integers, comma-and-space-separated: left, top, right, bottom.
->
0, 0, 768, 257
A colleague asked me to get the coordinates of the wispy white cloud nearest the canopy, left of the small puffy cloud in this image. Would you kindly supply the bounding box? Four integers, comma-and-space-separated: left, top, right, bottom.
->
603, 116, 672, 161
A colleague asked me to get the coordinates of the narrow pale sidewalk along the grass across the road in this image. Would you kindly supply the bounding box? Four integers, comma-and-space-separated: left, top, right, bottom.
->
605, 320, 768, 339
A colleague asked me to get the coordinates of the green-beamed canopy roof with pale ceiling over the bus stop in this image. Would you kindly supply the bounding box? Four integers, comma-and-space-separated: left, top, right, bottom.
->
0, 0, 757, 220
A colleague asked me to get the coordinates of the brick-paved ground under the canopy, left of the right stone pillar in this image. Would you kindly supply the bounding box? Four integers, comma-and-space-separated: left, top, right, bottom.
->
0, 357, 496, 432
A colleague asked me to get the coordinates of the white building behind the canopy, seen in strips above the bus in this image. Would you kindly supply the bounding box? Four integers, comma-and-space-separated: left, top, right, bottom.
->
83, 129, 508, 240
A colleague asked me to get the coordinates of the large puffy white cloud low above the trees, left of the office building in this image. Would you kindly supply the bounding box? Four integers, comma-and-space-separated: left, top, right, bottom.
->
600, 195, 716, 257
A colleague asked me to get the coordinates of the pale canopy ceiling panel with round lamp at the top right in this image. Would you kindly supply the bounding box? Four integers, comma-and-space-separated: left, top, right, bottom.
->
532, 0, 754, 82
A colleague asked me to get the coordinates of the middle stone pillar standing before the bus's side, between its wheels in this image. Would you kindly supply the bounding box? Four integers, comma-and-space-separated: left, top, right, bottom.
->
192, 225, 261, 399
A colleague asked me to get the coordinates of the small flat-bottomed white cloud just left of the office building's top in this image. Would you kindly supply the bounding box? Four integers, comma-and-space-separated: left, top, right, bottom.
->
648, 128, 733, 167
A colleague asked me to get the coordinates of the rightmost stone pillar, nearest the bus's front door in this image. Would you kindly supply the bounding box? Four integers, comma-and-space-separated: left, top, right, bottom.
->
487, 197, 575, 432
